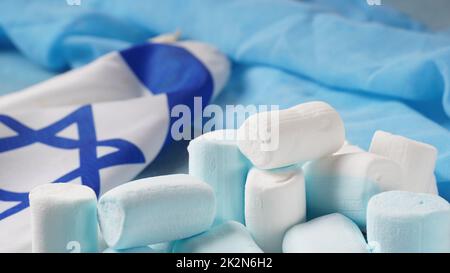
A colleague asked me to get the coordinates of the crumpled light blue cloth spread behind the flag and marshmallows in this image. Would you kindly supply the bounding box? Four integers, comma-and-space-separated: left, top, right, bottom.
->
0, 0, 450, 200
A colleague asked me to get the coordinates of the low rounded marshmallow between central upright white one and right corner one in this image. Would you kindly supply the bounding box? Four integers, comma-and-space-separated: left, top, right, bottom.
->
283, 213, 369, 253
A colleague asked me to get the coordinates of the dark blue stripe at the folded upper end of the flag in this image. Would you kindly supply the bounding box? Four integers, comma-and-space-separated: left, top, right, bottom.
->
120, 43, 214, 114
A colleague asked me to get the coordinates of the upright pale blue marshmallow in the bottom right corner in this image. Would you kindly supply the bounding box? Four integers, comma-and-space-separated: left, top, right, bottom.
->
367, 191, 450, 253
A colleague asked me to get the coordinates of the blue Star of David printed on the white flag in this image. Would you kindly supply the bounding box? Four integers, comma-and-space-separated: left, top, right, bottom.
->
0, 105, 145, 220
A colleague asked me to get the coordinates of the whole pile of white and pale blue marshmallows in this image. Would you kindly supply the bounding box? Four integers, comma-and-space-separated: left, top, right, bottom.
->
30, 102, 450, 253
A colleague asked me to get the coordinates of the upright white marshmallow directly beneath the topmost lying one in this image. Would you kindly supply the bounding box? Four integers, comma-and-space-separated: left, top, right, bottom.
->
245, 166, 306, 252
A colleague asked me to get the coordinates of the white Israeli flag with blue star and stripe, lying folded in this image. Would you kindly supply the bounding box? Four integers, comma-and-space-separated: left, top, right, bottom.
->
0, 38, 230, 252
